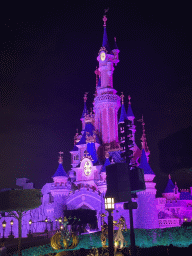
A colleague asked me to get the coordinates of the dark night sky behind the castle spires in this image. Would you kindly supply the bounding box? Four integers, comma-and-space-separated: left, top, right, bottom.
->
0, 1, 192, 195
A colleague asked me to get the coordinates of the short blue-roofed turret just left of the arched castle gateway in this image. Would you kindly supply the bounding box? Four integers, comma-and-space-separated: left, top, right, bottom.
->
51, 152, 71, 218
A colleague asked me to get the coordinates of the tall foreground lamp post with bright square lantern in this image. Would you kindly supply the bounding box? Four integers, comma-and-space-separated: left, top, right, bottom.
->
105, 197, 114, 256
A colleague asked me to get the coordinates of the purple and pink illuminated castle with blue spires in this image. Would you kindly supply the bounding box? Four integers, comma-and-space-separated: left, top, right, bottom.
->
0, 16, 192, 236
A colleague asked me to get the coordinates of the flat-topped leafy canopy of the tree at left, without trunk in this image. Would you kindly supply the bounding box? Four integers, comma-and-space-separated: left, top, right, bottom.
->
0, 189, 42, 212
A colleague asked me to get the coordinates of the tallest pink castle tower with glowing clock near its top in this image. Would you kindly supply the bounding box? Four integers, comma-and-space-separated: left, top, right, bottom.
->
94, 16, 120, 148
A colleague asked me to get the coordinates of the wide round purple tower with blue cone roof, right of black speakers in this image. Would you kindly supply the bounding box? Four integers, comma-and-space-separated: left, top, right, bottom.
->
136, 149, 159, 229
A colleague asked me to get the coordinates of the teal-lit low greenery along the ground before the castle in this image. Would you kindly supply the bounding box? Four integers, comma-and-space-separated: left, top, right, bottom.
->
14, 227, 192, 256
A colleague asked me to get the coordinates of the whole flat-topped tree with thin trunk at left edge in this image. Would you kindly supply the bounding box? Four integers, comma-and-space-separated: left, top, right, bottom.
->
0, 189, 42, 256
